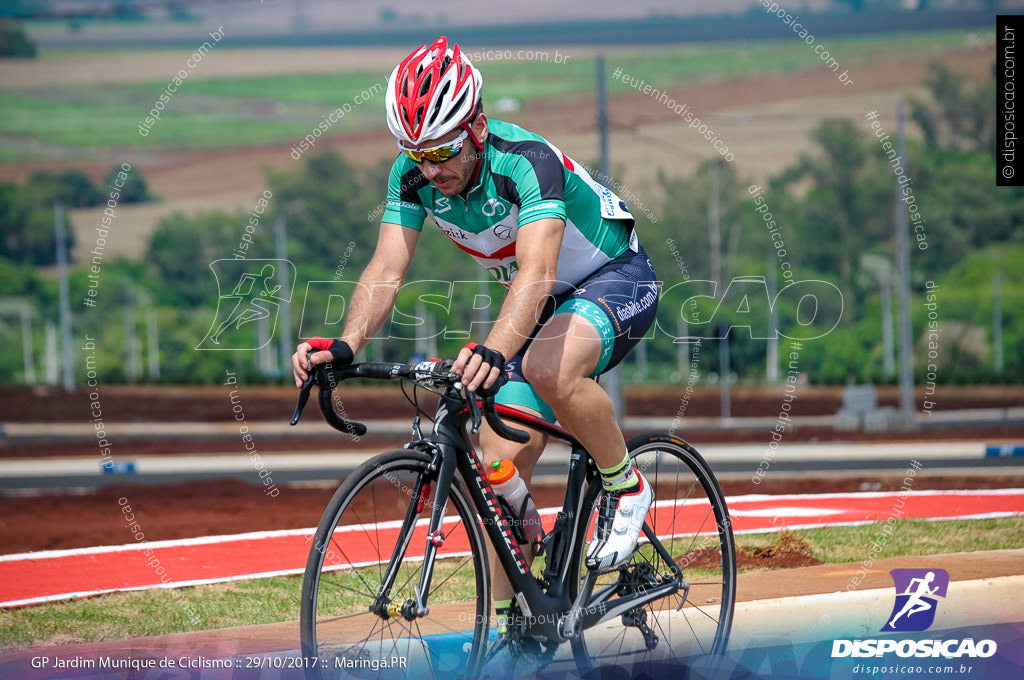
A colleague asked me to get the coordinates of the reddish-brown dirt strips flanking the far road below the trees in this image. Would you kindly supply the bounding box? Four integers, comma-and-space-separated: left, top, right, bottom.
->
0, 385, 1024, 459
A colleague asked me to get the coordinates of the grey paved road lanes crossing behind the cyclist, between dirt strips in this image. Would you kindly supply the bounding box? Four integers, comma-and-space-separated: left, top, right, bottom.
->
6, 408, 1024, 496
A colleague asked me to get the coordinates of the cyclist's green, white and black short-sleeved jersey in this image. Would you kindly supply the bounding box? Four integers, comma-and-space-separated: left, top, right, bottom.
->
382, 121, 637, 294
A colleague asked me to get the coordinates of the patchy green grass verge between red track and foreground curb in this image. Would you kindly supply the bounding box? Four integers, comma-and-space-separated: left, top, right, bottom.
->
0, 517, 1024, 648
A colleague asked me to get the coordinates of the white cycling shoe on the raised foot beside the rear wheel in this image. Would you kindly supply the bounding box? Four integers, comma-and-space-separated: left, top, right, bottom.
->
587, 470, 654, 571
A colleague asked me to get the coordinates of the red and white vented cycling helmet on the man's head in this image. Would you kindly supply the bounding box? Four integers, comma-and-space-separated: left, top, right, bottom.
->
385, 36, 483, 146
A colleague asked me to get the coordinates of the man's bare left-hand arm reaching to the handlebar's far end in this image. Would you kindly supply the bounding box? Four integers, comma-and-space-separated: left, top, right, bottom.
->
292, 222, 420, 386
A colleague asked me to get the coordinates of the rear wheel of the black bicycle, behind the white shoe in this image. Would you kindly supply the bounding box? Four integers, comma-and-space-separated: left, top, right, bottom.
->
572, 433, 736, 678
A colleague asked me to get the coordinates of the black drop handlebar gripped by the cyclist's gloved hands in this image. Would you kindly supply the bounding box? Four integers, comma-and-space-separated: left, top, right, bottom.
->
291, 360, 529, 443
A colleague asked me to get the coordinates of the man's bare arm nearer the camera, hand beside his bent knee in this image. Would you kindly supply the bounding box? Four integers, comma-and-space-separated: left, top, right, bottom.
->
454, 217, 565, 391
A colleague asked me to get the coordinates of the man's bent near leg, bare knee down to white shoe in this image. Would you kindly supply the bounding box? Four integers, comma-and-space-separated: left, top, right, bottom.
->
523, 313, 653, 569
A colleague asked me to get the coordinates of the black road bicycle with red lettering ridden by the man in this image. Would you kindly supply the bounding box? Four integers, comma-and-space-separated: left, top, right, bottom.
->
292, 360, 736, 678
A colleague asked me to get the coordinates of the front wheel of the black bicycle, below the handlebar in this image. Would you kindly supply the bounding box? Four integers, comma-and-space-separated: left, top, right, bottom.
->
300, 450, 490, 678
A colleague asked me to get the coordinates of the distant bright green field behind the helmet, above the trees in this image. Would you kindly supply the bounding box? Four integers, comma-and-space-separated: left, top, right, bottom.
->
0, 30, 988, 158
